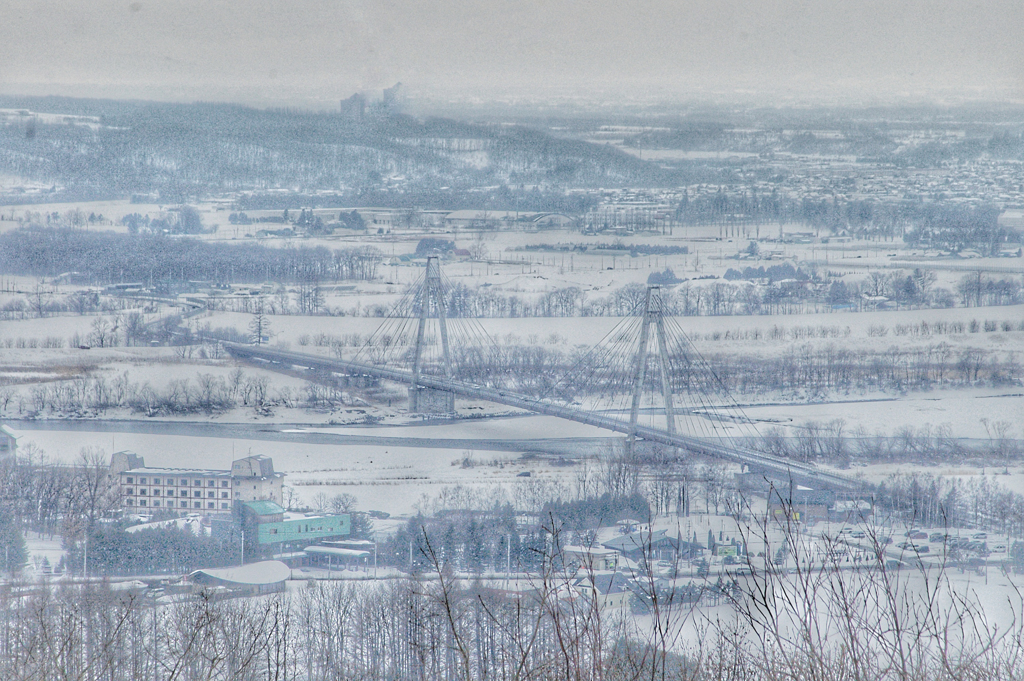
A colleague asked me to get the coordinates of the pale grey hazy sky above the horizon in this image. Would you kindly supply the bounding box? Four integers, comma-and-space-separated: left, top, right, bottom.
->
0, 0, 1024, 103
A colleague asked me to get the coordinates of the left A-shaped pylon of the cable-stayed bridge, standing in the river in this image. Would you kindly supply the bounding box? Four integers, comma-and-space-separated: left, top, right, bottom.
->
409, 256, 455, 414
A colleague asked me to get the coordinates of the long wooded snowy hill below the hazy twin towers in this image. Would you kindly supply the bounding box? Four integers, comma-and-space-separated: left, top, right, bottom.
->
0, 97, 676, 201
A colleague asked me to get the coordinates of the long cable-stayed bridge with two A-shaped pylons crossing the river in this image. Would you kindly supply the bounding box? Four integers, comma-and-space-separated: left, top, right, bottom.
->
225, 258, 863, 493
